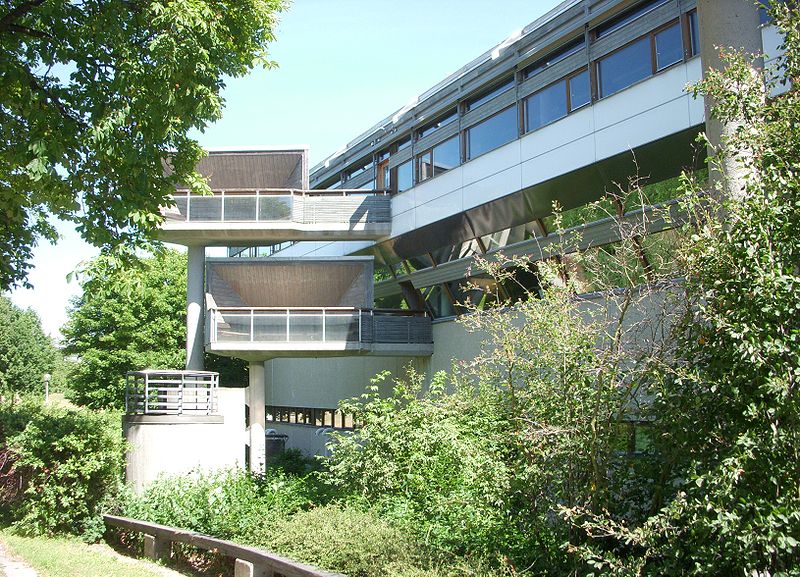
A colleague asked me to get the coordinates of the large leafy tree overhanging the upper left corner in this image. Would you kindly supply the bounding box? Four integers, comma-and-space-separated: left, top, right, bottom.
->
0, 0, 285, 289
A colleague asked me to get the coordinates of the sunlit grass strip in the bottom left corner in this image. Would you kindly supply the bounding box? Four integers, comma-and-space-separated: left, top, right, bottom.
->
0, 531, 180, 577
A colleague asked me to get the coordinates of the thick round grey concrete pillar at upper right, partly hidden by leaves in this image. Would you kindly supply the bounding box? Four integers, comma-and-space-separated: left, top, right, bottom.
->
697, 0, 763, 195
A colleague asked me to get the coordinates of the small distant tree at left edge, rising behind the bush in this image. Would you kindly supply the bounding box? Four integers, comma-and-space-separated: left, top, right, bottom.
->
0, 296, 59, 395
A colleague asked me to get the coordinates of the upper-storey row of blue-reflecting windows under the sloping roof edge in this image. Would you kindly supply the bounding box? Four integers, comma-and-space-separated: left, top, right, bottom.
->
328, 0, 699, 192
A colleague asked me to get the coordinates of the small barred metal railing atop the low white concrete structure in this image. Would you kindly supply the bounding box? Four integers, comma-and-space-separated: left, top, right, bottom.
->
125, 371, 219, 415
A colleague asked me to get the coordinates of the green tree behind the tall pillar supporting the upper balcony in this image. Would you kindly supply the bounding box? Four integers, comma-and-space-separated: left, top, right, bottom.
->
62, 250, 246, 409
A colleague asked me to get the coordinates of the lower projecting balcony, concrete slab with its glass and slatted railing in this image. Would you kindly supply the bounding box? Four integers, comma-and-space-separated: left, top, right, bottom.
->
206, 307, 433, 360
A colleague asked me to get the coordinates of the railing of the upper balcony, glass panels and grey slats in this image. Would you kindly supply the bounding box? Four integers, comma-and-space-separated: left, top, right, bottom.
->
162, 189, 391, 225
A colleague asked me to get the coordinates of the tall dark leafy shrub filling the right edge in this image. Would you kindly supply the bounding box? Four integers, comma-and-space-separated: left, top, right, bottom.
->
568, 4, 800, 575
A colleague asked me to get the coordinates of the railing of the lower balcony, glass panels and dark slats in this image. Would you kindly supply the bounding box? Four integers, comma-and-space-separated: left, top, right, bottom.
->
208, 307, 433, 345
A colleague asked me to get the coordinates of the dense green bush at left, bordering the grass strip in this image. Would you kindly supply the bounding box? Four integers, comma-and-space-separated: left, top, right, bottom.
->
0, 403, 123, 540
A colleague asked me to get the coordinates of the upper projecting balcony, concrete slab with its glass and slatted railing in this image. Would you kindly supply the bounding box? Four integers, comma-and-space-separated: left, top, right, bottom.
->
160, 189, 392, 246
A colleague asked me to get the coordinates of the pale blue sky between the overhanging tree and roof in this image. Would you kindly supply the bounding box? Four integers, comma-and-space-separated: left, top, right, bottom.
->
11, 0, 559, 338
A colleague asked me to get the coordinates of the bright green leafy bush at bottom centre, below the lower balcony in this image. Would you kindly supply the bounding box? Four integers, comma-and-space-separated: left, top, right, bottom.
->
325, 372, 518, 555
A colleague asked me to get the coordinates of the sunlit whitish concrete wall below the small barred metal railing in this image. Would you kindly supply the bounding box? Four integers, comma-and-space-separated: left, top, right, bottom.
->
122, 389, 245, 492
